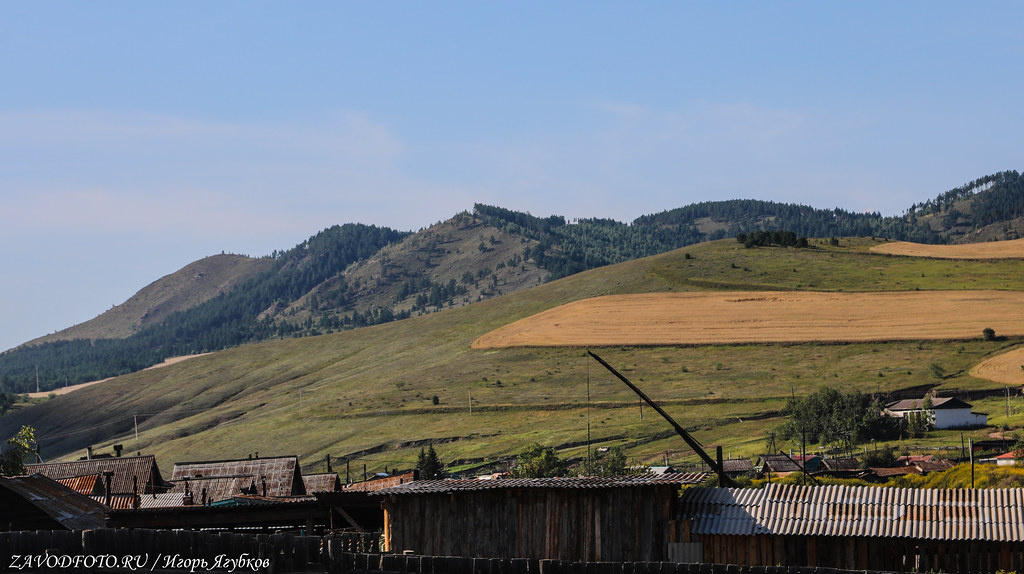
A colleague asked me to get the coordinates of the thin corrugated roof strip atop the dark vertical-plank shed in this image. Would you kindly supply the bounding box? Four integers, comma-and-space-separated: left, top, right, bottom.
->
371, 473, 709, 494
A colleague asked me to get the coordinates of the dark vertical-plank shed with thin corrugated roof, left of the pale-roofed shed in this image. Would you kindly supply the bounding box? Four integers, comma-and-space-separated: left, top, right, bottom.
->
373, 473, 707, 562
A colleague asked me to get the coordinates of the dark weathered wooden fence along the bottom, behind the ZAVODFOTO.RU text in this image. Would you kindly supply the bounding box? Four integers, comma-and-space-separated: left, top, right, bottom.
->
0, 529, 897, 574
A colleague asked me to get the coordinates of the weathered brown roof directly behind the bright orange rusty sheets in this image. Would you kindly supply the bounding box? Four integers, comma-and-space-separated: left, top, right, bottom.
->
25, 454, 166, 494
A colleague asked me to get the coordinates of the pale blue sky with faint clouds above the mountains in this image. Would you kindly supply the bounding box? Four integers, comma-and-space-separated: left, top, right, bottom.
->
0, 1, 1024, 350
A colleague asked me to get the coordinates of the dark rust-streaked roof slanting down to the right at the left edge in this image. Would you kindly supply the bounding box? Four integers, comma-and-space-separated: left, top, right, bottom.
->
0, 474, 106, 530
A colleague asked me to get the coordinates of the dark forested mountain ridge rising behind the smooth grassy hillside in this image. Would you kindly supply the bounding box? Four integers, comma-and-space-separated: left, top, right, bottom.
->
0, 171, 1024, 392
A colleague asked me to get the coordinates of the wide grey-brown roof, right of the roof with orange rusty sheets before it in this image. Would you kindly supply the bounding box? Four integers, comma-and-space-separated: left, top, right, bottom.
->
171, 455, 306, 501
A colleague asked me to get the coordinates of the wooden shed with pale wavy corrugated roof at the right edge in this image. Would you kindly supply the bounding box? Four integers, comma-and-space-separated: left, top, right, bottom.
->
680, 484, 1024, 574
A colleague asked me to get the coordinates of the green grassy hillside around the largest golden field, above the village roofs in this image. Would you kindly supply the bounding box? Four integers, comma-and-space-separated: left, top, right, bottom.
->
0, 238, 1024, 475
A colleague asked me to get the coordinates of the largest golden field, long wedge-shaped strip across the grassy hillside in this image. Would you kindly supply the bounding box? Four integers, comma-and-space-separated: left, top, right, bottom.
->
473, 291, 1024, 348
